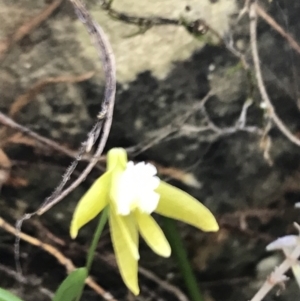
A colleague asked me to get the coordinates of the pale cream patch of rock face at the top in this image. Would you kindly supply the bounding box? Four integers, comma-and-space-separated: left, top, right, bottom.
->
72, 0, 236, 83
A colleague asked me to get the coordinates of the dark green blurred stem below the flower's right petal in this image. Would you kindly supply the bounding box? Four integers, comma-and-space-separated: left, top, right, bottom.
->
163, 217, 204, 301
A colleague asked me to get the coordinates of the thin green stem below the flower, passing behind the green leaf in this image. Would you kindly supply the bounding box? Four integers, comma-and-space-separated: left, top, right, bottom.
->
76, 206, 109, 301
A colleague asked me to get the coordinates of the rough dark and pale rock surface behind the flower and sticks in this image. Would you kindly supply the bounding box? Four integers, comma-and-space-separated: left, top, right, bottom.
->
0, 0, 300, 301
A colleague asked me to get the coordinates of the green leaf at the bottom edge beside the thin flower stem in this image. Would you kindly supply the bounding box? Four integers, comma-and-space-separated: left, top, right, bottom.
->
52, 268, 88, 301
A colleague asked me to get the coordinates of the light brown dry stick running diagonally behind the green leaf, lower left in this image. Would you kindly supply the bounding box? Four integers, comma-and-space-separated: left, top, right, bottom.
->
0, 217, 117, 301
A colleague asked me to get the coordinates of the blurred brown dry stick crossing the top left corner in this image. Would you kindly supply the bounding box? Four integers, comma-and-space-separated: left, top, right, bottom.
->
0, 0, 62, 60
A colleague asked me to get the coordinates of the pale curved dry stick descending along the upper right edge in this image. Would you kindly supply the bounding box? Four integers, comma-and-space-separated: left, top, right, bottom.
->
249, 1, 300, 146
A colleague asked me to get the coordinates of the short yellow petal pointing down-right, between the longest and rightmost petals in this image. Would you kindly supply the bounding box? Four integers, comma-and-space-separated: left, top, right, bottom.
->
135, 210, 171, 257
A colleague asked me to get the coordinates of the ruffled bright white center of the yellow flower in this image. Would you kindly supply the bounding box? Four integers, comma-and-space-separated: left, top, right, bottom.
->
116, 161, 160, 215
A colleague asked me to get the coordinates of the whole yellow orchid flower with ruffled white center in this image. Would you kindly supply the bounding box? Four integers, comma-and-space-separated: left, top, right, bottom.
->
70, 148, 219, 295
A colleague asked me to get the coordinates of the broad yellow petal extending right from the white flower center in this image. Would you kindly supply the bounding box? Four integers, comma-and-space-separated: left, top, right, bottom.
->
155, 181, 219, 231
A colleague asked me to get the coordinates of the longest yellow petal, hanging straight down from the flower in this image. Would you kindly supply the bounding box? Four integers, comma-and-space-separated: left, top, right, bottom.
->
109, 210, 140, 295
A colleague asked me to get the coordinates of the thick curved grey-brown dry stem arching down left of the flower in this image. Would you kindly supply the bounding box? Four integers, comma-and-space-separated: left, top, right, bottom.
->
35, 0, 116, 213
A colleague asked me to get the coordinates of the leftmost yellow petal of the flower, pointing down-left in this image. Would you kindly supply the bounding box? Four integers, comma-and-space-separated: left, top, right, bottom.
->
70, 172, 111, 238
